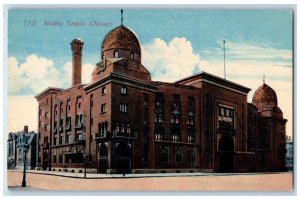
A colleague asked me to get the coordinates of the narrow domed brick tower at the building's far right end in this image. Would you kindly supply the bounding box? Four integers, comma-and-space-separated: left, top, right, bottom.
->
252, 82, 287, 171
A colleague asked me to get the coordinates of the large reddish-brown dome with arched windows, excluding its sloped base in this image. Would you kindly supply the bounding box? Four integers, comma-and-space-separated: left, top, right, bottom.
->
101, 25, 141, 63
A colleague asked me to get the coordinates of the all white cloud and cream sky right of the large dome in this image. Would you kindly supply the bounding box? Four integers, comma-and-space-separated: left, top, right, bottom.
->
143, 38, 292, 138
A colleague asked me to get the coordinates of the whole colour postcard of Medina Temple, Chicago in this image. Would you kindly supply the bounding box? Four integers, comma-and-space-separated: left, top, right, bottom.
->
5, 7, 294, 192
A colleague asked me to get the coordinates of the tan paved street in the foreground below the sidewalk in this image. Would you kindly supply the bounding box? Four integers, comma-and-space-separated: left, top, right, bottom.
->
7, 170, 293, 192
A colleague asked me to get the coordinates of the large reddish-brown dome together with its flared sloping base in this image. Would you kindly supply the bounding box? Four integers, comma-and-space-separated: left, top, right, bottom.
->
92, 25, 151, 83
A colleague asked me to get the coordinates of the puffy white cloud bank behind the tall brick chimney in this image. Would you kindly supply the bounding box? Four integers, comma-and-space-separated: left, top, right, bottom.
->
8, 54, 94, 95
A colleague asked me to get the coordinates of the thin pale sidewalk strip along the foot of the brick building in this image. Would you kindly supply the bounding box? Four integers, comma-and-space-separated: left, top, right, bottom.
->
10, 170, 291, 179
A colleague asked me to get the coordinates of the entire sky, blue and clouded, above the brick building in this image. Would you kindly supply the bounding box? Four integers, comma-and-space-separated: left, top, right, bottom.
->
7, 9, 293, 139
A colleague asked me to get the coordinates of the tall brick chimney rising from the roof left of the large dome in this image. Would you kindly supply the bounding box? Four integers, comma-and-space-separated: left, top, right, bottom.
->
70, 39, 84, 86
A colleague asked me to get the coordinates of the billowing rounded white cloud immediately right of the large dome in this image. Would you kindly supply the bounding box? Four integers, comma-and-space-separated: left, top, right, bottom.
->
143, 37, 200, 82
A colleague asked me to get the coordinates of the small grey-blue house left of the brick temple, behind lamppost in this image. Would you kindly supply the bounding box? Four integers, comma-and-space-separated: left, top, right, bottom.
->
7, 126, 38, 169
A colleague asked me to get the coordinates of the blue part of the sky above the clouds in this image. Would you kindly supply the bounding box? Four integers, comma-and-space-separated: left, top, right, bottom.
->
8, 9, 292, 68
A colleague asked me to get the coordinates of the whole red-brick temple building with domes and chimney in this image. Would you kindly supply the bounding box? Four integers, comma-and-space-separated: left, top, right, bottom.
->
36, 25, 287, 173
